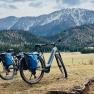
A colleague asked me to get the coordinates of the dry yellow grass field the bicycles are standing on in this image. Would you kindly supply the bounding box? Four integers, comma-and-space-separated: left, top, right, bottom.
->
0, 53, 94, 94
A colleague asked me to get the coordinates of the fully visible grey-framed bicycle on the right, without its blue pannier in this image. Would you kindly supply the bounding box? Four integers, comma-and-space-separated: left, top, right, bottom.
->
20, 40, 68, 85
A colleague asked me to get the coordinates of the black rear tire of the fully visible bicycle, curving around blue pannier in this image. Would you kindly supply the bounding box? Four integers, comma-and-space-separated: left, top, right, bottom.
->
20, 57, 45, 85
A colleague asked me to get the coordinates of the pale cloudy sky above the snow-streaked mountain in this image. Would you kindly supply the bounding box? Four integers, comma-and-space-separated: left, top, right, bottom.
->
0, 0, 94, 18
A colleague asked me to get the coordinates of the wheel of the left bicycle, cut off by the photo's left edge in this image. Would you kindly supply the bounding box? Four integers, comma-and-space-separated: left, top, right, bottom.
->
0, 60, 15, 80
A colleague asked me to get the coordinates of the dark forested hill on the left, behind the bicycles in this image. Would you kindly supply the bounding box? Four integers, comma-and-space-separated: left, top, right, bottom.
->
0, 30, 48, 50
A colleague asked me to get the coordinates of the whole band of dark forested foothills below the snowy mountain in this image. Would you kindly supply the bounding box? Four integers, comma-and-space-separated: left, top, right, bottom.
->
0, 24, 94, 51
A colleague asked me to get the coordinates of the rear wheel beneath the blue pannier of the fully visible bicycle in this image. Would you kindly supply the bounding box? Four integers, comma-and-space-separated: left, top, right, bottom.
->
20, 58, 44, 85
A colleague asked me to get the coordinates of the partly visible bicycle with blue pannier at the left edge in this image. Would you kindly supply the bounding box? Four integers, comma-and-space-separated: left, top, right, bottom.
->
0, 49, 23, 80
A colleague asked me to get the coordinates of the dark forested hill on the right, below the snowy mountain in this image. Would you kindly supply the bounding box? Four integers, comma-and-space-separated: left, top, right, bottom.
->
48, 24, 94, 50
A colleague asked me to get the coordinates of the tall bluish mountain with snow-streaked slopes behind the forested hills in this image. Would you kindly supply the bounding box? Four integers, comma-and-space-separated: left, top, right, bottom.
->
0, 8, 94, 36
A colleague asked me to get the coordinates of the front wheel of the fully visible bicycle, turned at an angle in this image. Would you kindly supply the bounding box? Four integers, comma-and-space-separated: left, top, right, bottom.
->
55, 54, 68, 78
